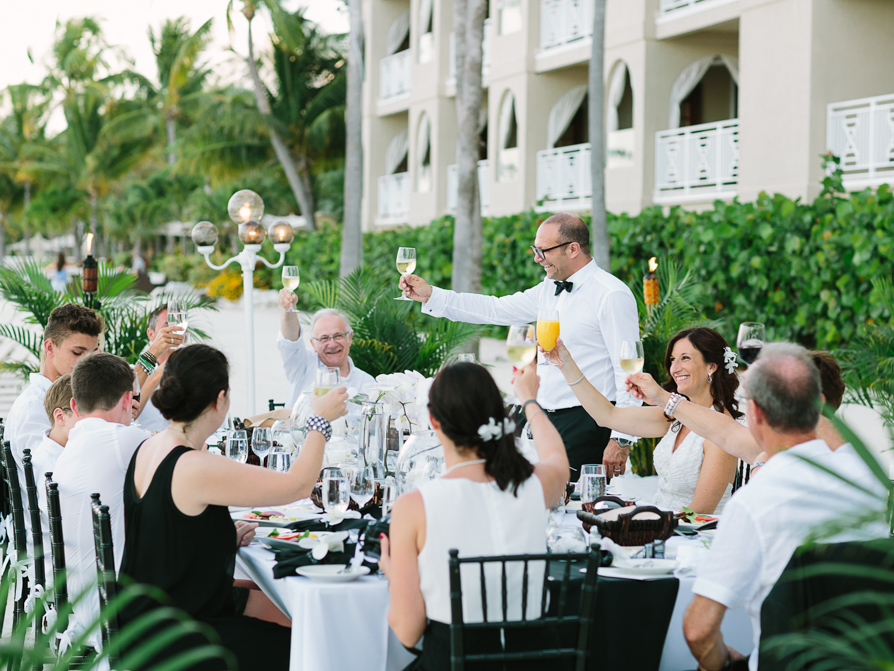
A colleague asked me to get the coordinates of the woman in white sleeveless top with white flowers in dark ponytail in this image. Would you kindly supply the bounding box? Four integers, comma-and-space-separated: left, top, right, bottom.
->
379, 363, 568, 669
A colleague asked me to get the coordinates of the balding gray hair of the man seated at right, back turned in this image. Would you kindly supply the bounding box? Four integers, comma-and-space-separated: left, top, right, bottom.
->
745, 342, 822, 433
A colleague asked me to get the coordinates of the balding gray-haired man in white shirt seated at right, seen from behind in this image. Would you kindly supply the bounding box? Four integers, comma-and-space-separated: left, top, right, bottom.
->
680, 343, 889, 671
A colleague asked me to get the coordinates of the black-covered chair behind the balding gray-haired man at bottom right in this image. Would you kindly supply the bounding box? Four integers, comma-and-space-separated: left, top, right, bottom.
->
752, 538, 894, 671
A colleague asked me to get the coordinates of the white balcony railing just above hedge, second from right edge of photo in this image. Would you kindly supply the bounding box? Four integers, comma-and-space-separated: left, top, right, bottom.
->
655, 119, 739, 202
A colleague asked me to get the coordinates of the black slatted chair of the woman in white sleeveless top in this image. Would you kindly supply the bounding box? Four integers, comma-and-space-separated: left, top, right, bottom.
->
448, 548, 601, 671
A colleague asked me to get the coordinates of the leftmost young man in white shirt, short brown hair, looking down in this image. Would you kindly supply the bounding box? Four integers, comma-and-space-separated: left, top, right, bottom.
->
3, 303, 104, 545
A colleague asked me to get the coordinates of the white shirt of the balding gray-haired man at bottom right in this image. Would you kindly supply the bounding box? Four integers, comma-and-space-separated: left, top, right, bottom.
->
692, 439, 890, 671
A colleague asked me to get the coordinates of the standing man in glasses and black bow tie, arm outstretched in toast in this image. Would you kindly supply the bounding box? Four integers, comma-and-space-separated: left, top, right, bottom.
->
400, 213, 640, 480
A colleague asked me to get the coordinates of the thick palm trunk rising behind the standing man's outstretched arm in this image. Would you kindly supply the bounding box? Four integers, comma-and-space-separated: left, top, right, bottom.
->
452, 0, 487, 293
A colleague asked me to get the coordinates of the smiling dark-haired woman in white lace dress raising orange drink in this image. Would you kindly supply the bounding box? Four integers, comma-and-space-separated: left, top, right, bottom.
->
550, 327, 744, 513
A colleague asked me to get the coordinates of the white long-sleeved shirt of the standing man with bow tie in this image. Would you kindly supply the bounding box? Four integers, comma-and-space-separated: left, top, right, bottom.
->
422, 259, 642, 438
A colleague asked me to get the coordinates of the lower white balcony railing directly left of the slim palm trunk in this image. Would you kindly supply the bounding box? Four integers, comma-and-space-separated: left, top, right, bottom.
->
537, 142, 593, 209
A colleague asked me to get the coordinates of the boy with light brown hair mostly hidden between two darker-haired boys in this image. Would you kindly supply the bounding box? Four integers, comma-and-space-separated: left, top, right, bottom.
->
31, 373, 78, 584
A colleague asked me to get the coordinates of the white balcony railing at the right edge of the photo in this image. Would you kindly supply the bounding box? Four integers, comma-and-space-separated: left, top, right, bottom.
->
826, 94, 894, 187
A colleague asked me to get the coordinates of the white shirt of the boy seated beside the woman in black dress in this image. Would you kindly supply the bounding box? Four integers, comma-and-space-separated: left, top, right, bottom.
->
53, 417, 149, 630
